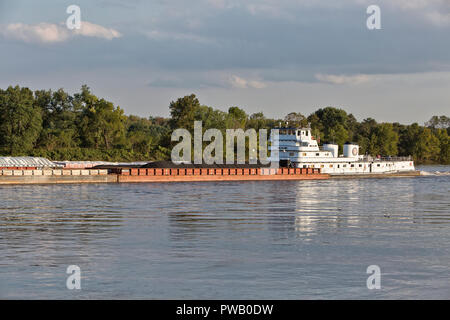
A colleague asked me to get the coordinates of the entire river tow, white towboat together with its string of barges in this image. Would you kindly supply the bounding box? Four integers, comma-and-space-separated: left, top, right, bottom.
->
0, 128, 420, 185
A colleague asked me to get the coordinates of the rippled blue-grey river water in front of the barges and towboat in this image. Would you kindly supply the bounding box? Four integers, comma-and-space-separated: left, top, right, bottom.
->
0, 166, 450, 299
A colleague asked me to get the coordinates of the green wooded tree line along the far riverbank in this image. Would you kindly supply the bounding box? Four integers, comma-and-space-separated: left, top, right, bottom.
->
0, 86, 450, 164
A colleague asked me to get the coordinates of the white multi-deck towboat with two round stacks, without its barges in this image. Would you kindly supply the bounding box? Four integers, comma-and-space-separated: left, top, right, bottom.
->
271, 128, 415, 175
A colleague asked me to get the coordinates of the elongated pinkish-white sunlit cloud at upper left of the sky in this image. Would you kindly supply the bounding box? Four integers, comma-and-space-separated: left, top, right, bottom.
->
0, 21, 122, 44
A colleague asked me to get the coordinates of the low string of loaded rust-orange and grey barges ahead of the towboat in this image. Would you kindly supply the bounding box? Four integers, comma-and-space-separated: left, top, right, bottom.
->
0, 157, 329, 185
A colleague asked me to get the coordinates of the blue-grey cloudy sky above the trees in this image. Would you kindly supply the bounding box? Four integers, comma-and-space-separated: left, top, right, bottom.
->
0, 0, 450, 124
